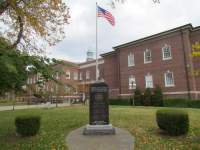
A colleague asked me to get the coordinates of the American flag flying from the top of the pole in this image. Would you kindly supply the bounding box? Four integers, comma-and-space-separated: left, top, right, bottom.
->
97, 6, 115, 26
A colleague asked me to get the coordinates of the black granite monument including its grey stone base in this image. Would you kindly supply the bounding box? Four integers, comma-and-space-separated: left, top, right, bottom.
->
83, 82, 115, 135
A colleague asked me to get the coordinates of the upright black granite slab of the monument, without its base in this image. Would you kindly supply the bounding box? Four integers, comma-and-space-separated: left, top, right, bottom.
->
90, 83, 109, 125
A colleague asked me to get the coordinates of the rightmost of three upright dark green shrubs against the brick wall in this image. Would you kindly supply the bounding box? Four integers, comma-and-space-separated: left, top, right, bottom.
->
151, 86, 163, 106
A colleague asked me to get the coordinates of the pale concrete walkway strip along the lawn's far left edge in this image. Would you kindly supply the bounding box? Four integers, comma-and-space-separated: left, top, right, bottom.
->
0, 103, 70, 111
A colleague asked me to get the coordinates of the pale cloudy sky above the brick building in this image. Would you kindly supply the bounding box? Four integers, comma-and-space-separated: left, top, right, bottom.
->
46, 0, 200, 62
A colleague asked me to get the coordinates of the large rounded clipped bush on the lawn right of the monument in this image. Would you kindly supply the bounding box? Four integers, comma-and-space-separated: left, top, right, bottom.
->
156, 109, 189, 136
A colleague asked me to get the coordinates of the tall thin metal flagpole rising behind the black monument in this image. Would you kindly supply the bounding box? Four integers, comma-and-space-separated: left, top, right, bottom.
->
96, 2, 98, 81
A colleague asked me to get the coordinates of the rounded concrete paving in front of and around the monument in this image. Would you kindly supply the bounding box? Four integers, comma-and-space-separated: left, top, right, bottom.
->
66, 127, 134, 150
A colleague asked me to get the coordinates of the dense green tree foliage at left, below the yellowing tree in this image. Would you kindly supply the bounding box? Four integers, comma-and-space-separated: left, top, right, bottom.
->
0, 38, 59, 95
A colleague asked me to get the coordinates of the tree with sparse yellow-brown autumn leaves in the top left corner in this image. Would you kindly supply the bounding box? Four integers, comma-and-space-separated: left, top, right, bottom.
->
0, 0, 70, 52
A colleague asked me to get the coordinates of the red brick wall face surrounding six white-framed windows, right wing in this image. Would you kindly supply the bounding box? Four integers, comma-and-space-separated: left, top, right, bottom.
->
118, 33, 188, 97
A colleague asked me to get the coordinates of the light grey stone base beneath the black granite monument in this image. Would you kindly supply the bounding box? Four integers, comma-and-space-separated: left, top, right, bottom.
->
83, 124, 115, 135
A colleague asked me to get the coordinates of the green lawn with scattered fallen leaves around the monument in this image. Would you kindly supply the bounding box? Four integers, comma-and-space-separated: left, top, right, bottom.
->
0, 106, 200, 150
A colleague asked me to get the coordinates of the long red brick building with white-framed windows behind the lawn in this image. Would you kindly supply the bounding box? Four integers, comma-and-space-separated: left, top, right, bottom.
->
26, 24, 200, 99
